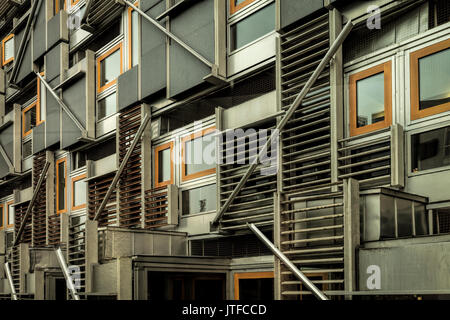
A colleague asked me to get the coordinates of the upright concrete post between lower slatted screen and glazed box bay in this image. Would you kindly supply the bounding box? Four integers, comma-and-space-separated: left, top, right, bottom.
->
343, 179, 360, 299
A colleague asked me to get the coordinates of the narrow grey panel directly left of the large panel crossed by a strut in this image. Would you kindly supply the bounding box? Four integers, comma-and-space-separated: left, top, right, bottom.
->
141, 44, 166, 98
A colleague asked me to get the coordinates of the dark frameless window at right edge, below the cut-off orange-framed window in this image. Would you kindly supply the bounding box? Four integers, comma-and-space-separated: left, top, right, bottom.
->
411, 127, 450, 172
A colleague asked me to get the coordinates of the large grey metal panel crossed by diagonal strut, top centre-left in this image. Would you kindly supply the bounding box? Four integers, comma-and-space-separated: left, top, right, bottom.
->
169, 0, 214, 97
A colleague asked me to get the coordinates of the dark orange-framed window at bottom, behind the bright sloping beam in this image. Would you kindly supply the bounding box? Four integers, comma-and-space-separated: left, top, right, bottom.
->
234, 271, 274, 300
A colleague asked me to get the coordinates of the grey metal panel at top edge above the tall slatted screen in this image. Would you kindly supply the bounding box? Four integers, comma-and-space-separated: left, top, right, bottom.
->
280, 0, 323, 29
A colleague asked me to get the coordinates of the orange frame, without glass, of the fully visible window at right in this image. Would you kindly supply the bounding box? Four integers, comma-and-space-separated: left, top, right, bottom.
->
349, 61, 392, 136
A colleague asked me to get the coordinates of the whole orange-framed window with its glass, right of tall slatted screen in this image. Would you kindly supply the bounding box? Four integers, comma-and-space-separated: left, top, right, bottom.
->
349, 61, 392, 136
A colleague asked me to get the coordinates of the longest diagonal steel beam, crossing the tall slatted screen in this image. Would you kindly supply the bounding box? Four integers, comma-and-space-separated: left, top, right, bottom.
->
213, 20, 353, 225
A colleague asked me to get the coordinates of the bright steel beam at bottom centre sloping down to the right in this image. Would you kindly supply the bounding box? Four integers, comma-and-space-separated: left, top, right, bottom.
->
247, 223, 330, 300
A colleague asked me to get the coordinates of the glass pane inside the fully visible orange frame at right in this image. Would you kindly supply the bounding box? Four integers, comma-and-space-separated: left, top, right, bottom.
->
356, 72, 384, 128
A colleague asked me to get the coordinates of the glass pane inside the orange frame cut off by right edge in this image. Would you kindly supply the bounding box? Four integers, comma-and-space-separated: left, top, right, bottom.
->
419, 49, 450, 110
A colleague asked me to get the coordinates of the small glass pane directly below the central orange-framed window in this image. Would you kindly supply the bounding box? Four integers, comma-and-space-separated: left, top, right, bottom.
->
182, 184, 216, 215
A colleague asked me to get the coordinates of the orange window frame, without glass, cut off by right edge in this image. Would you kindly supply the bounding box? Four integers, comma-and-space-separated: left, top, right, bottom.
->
409, 39, 450, 120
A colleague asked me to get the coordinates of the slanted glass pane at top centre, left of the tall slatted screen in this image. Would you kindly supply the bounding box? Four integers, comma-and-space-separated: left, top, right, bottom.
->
231, 3, 275, 51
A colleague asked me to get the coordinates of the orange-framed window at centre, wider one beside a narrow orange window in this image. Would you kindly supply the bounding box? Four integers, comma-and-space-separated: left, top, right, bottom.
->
181, 127, 216, 181
